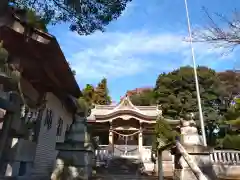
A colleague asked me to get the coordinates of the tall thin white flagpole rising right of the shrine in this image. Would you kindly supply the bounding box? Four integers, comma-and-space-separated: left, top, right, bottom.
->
184, 0, 207, 146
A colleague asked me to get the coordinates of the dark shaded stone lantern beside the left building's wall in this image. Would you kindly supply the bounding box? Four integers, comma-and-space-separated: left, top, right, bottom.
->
51, 98, 94, 180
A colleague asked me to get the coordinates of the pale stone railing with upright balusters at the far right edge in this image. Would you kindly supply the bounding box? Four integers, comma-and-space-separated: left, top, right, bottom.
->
210, 150, 240, 165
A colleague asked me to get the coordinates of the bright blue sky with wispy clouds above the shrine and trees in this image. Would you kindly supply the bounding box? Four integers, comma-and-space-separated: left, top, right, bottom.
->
49, 0, 240, 101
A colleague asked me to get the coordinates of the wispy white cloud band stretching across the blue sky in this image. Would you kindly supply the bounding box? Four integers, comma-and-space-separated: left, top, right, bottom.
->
60, 31, 236, 80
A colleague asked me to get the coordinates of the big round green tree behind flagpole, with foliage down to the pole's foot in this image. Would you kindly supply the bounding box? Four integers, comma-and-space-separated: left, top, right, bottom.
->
155, 66, 225, 146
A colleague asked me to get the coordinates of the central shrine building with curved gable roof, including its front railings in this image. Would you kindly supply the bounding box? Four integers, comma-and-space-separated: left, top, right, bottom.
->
87, 97, 179, 169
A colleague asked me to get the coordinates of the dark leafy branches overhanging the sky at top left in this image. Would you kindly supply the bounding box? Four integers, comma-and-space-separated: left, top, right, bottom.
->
0, 0, 131, 35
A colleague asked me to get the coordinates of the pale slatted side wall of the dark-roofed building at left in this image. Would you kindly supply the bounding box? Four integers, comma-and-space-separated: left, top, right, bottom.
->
33, 93, 71, 175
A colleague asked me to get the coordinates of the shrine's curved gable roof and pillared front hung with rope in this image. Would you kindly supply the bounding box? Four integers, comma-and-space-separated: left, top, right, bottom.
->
88, 96, 179, 158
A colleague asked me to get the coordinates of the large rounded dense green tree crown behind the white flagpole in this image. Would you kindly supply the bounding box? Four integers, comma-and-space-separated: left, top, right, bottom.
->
155, 66, 220, 118
